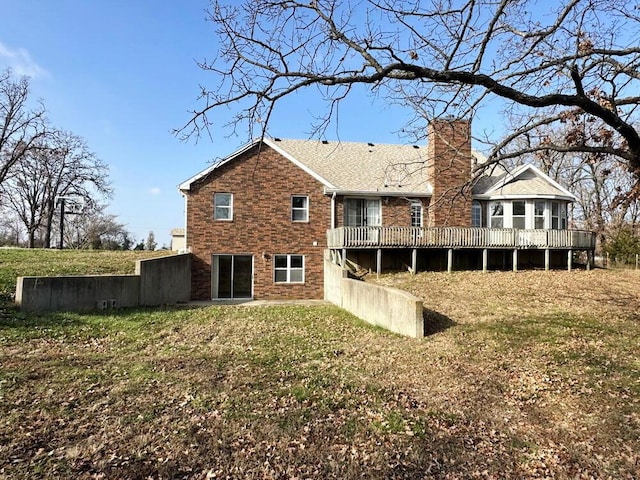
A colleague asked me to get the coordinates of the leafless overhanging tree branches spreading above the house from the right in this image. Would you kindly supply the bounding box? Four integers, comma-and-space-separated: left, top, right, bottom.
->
181, 0, 640, 190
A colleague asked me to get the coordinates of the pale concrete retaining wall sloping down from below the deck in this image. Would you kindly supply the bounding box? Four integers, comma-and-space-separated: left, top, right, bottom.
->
324, 259, 424, 338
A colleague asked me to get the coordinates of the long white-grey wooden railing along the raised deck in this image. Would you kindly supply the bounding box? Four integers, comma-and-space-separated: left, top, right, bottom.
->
327, 227, 596, 249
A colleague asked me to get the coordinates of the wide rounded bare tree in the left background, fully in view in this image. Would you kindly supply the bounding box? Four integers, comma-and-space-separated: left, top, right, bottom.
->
0, 130, 112, 248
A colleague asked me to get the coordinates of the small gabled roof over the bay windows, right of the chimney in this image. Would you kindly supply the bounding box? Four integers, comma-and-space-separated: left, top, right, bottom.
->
473, 164, 576, 202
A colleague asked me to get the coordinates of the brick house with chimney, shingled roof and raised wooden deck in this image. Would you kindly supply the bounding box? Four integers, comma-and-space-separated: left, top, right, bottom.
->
179, 120, 595, 299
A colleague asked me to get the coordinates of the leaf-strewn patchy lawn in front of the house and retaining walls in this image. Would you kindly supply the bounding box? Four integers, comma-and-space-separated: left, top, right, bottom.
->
0, 252, 640, 479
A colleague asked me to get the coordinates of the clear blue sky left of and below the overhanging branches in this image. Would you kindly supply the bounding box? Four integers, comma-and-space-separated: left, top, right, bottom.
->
0, 0, 500, 245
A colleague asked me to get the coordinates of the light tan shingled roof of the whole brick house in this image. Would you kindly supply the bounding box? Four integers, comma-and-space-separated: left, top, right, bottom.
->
179, 138, 575, 200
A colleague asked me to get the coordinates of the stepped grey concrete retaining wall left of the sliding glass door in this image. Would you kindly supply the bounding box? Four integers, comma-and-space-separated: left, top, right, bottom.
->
16, 254, 191, 312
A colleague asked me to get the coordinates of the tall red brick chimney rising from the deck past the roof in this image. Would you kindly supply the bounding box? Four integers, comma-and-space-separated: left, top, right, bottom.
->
427, 119, 471, 227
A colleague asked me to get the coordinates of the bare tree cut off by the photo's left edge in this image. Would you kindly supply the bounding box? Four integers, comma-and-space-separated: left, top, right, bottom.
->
0, 70, 46, 185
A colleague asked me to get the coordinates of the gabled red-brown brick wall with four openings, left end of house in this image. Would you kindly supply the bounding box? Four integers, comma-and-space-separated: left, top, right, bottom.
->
187, 142, 331, 300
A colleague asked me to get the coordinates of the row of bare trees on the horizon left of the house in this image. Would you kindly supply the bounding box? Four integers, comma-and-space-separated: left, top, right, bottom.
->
0, 69, 133, 250
